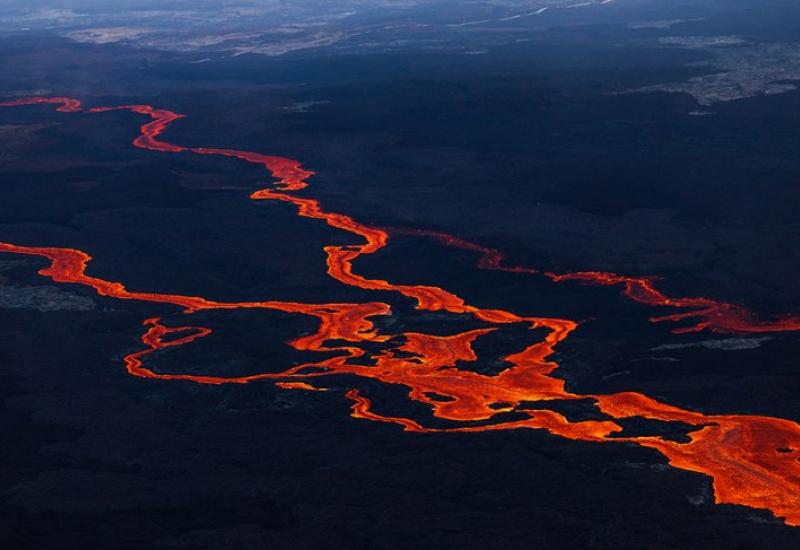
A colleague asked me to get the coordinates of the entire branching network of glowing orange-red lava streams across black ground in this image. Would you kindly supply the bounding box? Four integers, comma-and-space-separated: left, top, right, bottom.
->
0, 97, 800, 526
